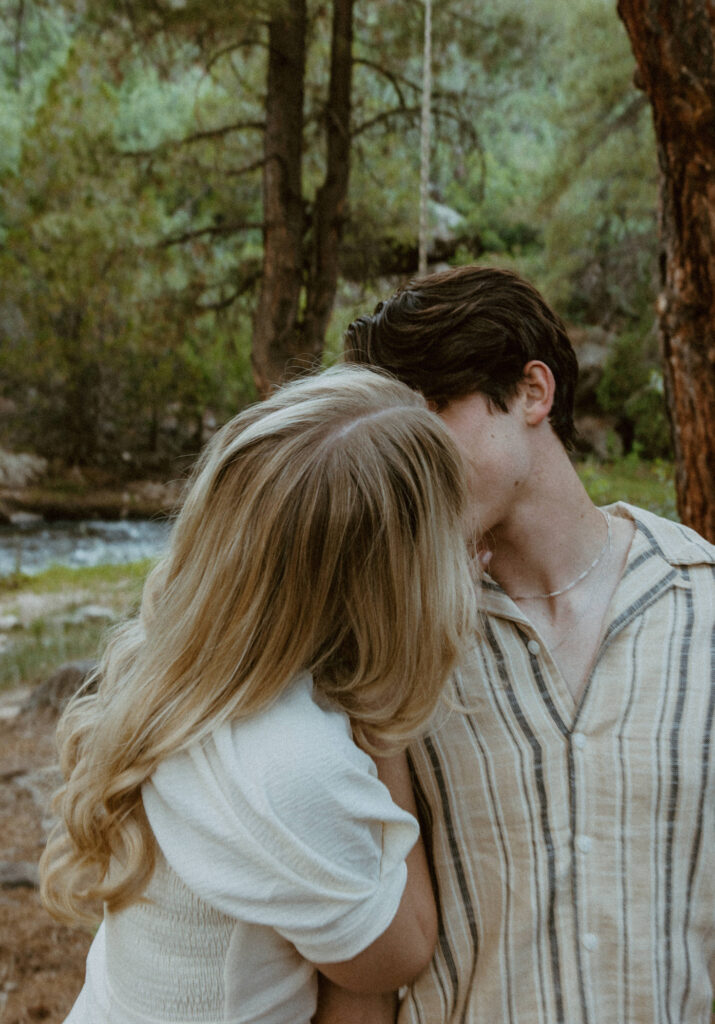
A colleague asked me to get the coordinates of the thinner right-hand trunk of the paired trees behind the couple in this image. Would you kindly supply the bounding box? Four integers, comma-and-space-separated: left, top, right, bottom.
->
304, 0, 354, 361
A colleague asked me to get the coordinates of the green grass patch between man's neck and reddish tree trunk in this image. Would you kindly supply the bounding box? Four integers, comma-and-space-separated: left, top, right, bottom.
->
576, 455, 678, 522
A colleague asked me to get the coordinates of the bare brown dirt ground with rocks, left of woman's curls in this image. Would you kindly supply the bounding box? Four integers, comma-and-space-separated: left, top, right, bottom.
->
0, 690, 91, 1024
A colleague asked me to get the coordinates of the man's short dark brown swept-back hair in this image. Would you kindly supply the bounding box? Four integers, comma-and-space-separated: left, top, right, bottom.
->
344, 266, 578, 449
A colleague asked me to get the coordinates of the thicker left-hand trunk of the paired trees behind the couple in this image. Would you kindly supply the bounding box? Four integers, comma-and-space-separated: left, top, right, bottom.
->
251, 0, 307, 396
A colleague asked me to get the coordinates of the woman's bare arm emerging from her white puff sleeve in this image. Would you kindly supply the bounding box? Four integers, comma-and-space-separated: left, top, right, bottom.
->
316, 754, 437, 994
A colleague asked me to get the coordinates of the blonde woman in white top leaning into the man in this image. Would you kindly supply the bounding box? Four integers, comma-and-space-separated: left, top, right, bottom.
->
41, 368, 473, 1024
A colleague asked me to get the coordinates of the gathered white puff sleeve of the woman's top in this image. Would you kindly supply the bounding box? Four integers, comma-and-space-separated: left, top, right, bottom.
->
142, 677, 419, 963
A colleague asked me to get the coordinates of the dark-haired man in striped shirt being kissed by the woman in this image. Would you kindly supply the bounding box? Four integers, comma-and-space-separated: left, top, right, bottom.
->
325, 266, 715, 1024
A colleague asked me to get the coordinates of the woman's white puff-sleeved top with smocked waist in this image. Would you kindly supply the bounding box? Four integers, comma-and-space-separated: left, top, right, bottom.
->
68, 676, 418, 1024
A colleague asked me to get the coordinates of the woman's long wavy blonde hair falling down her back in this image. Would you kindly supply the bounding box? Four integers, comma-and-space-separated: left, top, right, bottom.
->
41, 367, 474, 923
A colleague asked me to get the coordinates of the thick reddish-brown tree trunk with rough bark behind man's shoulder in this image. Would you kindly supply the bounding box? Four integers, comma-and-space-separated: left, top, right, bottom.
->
618, 0, 715, 542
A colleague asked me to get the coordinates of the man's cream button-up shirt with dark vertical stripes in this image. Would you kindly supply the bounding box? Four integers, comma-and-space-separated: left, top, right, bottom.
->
398, 505, 715, 1024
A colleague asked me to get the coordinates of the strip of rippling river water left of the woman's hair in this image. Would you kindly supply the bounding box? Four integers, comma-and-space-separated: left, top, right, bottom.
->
0, 519, 170, 578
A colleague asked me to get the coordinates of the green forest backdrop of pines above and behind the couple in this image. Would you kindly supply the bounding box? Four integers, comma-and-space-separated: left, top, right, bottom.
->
0, 0, 672, 480
